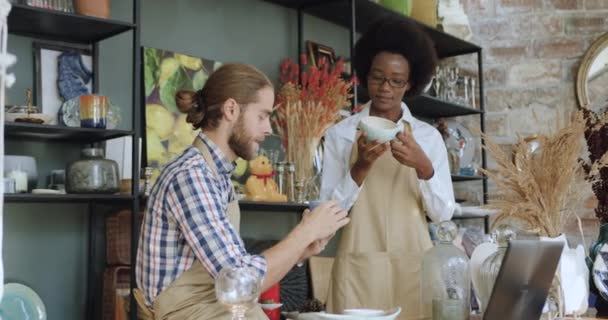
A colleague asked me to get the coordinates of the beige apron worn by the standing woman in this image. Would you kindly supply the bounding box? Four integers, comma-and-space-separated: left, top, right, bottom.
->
327, 125, 432, 320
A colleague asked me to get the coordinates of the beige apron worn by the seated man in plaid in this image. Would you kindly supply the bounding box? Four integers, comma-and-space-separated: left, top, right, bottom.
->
135, 137, 268, 320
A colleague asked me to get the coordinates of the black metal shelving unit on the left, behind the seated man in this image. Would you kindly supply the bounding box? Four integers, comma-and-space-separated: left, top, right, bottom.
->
4, 0, 141, 320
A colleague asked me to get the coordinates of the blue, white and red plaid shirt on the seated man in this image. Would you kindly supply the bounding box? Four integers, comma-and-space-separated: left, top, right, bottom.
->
136, 133, 266, 306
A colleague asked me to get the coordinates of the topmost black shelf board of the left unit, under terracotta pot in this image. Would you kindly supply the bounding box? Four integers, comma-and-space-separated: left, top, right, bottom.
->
8, 4, 136, 43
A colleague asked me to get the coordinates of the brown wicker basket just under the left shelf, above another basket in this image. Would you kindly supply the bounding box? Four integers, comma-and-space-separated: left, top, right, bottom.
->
106, 210, 143, 265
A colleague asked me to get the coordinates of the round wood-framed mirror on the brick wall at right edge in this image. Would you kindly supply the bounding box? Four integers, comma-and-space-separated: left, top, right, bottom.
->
576, 33, 608, 112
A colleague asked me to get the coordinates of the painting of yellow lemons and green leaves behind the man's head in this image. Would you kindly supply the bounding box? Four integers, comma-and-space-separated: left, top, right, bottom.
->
143, 48, 221, 182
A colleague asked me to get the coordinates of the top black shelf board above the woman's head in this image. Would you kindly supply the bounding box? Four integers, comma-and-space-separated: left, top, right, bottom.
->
266, 0, 481, 58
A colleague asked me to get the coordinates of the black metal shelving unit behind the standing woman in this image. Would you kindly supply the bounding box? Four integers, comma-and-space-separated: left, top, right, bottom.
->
264, 0, 489, 232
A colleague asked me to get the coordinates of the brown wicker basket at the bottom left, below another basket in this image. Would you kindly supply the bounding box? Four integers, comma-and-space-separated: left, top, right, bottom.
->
102, 266, 131, 320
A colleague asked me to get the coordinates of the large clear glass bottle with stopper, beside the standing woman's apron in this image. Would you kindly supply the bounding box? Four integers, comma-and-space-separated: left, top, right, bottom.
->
421, 221, 471, 320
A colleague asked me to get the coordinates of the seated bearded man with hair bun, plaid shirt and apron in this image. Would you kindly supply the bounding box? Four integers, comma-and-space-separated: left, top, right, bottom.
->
136, 64, 349, 319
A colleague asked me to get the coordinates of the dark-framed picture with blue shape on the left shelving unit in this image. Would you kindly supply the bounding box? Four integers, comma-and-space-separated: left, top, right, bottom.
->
33, 42, 97, 119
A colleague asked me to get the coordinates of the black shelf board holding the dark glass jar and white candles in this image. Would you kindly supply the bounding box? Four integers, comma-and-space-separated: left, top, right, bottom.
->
4, 193, 134, 203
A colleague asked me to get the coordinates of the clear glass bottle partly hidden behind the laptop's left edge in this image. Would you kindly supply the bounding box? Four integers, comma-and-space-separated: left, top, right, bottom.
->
477, 224, 515, 311
